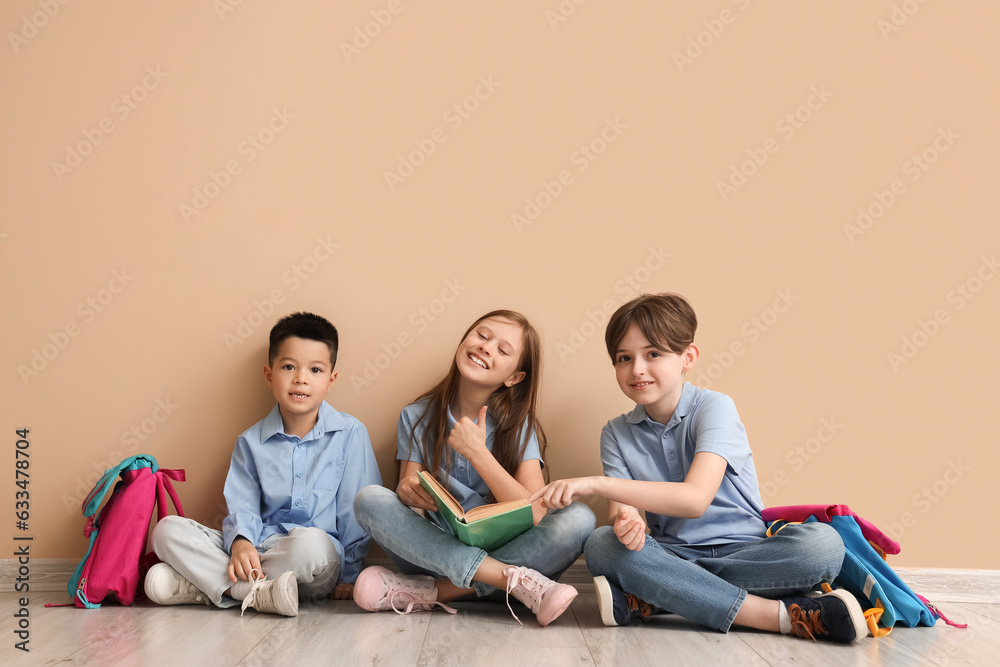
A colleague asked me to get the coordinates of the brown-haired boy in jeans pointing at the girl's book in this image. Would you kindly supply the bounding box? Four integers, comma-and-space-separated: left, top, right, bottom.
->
528, 294, 867, 642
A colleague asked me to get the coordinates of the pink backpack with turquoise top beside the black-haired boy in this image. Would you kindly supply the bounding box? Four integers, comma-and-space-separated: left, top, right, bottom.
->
67, 454, 184, 609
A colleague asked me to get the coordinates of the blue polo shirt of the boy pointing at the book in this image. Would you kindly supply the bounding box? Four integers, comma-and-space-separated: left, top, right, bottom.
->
601, 383, 764, 545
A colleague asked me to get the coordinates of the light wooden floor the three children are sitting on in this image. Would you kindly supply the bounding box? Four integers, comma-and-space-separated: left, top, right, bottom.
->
0, 566, 1000, 667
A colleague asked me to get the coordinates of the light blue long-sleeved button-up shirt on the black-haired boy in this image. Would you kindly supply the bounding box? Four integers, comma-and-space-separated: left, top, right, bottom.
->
222, 402, 382, 583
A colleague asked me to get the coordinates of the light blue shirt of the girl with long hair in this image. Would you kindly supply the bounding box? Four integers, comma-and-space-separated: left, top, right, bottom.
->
396, 399, 544, 511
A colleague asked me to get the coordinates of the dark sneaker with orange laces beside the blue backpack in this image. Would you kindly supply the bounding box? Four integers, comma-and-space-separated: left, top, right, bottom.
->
780, 588, 868, 644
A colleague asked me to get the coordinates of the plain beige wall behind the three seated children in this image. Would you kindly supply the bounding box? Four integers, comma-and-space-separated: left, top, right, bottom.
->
0, 0, 1000, 568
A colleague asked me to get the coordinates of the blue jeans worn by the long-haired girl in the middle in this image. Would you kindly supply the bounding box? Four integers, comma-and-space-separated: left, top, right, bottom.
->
354, 485, 595, 597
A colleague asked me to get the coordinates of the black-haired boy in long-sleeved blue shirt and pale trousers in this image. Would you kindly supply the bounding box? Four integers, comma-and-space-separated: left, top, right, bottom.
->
145, 313, 382, 616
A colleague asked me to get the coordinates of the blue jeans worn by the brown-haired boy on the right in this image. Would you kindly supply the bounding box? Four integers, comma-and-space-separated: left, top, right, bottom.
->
585, 523, 844, 632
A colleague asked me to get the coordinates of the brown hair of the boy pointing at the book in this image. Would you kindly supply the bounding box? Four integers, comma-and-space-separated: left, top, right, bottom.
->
604, 292, 698, 363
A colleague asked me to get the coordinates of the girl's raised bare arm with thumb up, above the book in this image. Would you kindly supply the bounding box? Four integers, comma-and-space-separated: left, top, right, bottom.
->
448, 405, 547, 524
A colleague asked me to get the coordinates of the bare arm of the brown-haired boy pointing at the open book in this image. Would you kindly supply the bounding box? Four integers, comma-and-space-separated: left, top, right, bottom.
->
528, 452, 727, 519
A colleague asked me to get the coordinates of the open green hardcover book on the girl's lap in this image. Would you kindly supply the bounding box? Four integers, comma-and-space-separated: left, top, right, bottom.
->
419, 470, 535, 551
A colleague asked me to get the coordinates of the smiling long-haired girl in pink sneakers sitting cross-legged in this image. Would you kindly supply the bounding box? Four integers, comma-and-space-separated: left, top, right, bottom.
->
354, 310, 595, 625
